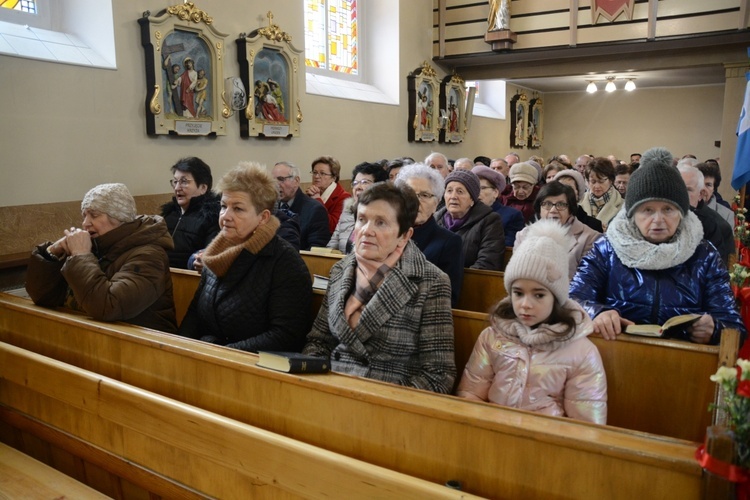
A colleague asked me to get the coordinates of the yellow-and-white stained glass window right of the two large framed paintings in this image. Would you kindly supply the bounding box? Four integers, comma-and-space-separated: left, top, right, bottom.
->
305, 0, 359, 75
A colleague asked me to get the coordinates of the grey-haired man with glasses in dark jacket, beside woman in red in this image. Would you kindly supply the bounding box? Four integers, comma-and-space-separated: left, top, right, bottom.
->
271, 161, 331, 250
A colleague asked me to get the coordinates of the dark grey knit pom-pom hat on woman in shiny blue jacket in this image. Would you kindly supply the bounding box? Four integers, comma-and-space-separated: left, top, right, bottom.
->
625, 148, 690, 217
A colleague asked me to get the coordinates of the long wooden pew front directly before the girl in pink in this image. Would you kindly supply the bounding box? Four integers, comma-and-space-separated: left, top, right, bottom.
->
0, 295, 712, 498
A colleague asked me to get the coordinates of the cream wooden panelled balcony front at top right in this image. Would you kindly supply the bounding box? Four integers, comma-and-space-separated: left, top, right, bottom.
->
433, 0, 743, 57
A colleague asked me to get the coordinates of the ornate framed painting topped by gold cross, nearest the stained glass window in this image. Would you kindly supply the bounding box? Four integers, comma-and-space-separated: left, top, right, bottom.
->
237, 12, 303, 137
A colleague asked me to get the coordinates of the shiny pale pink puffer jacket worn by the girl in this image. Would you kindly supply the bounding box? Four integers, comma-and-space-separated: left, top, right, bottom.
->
457, 299, 607, 424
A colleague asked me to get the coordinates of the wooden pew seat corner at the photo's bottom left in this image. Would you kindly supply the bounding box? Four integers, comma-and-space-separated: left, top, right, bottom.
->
0, 443, 109, 500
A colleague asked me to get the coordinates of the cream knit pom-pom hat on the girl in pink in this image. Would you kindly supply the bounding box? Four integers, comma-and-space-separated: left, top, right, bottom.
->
505, 219, 573, 304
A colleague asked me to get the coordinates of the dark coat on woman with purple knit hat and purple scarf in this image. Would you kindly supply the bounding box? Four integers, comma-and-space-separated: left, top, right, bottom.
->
435, 202, 505, 271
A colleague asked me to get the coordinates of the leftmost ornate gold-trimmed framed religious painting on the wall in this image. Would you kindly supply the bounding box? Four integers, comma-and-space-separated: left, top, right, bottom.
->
138, 2, 226, 136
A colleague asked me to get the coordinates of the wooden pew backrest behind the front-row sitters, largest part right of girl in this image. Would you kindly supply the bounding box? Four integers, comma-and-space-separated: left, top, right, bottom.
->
172, 269, 736, 441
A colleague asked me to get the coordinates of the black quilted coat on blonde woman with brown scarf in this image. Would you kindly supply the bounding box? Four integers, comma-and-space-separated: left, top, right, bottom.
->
179, 235, 312, 352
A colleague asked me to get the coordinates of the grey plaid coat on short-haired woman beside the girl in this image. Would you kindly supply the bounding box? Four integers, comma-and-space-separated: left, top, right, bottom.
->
303, 241, 456, 394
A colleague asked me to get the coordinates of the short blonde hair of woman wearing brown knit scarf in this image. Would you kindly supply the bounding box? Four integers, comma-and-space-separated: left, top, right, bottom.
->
214, 161, 279, 214
